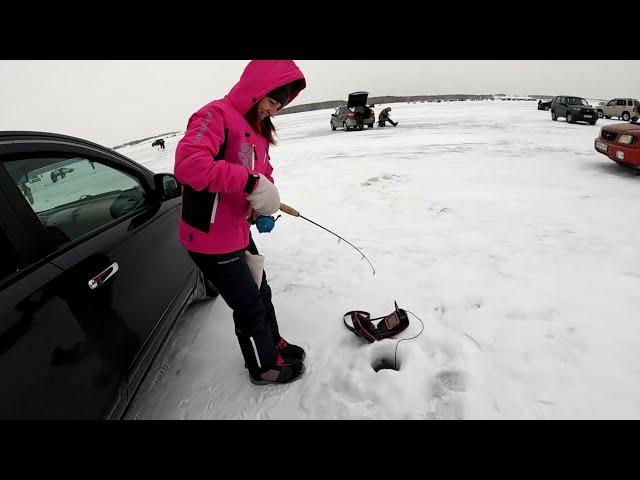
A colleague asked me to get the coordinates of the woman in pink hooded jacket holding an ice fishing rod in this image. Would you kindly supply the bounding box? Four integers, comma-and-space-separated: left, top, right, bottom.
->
174, 60, 306, 385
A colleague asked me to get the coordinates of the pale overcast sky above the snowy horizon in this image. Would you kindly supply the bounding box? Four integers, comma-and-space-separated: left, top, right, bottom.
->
0, 60, 640, 147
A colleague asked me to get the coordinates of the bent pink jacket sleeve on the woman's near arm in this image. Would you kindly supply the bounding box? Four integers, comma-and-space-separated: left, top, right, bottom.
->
173, 108, 249, 193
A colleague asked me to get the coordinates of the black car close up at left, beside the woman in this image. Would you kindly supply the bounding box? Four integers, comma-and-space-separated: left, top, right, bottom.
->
0, 132, 217, 419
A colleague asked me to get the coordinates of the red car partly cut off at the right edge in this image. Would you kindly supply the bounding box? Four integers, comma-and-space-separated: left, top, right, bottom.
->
593, 122, 640, 167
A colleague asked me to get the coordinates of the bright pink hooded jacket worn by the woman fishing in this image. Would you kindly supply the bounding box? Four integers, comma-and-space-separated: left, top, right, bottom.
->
174, 60, 306, 254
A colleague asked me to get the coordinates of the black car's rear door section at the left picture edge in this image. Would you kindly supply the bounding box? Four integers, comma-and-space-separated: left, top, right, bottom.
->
0, 157, 127, 419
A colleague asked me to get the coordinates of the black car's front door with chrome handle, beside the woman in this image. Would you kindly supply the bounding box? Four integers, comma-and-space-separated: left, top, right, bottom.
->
0, 135, 195, 416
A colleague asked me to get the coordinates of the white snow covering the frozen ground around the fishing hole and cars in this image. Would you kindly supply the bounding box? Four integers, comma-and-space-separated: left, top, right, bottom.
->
119, 101, 640, 419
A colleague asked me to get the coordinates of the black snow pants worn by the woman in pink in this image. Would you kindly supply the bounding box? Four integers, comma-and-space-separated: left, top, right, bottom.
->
189, 238, 280, 375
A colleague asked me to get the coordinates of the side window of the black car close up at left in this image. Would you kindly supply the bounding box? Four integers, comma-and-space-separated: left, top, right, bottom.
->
5, 157, 145, 246
